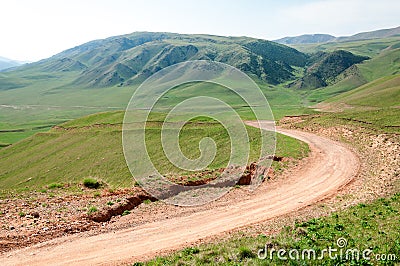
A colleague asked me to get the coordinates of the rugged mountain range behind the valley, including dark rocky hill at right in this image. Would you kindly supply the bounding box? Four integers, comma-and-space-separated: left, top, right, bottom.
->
0, 32, 376, 90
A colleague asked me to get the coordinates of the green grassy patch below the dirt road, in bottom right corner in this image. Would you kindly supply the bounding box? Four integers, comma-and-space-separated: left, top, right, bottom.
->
136, 193, 400, 265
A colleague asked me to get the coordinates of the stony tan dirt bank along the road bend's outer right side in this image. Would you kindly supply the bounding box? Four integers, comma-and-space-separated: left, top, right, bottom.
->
280, 116, 400, 202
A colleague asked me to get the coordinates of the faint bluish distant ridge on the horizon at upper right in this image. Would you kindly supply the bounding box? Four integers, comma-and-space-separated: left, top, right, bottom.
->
274, 26, 400, 44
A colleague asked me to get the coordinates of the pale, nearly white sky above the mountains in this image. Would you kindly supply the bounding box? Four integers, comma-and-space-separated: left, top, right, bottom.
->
0, 0, 400, 61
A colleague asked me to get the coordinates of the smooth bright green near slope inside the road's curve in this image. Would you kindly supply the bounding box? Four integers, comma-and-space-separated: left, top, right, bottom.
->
0, 112, 308, 193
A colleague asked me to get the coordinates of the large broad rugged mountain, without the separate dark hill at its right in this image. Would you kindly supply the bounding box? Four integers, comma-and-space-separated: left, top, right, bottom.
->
13, 32, 307, 87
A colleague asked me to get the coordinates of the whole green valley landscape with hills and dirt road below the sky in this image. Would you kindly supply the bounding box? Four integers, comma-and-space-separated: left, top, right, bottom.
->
0, 23, 400, 265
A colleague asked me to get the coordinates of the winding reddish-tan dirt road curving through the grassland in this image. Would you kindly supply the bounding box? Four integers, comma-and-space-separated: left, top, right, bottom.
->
0, 121, 359, 265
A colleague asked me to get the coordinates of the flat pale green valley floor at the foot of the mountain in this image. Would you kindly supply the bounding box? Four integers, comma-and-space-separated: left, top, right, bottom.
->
0, 78, 310, 144
